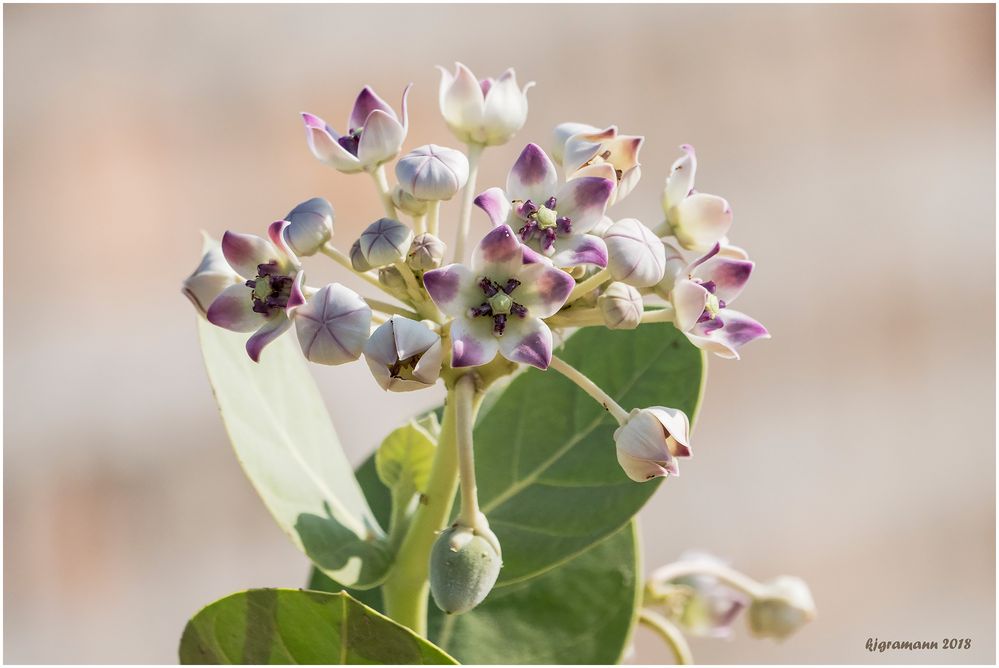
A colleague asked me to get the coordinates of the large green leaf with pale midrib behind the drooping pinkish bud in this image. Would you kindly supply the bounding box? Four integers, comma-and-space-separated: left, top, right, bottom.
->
475, 324, 704, 587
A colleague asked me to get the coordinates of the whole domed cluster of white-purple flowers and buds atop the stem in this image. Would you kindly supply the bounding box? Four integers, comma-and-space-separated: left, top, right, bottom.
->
184, 64, 769, 616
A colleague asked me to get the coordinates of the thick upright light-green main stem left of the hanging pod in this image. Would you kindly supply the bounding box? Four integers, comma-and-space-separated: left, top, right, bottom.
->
382, 379, 482, 637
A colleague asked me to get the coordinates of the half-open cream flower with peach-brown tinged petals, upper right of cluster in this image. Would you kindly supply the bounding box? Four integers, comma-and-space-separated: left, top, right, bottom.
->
552, 123, 645, 204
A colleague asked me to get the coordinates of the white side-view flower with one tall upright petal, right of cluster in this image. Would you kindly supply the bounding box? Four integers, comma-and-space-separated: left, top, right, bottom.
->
662, 144, 732, 253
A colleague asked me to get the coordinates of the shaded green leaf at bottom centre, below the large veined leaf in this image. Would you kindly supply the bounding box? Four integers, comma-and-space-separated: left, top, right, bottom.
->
430, 523, 641, 664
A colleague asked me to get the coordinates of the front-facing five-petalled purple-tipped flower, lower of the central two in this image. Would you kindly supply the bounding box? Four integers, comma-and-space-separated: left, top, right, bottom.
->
423, 225, 576, 369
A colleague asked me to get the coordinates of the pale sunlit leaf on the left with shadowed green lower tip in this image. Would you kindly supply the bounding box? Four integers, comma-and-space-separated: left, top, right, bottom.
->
198, 318, 391, 588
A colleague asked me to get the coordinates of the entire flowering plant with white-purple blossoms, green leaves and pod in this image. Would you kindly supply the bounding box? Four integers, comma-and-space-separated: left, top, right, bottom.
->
180, 64, 814, 663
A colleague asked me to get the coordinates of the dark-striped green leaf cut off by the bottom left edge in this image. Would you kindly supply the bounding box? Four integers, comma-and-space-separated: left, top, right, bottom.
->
180, 589, 456, 665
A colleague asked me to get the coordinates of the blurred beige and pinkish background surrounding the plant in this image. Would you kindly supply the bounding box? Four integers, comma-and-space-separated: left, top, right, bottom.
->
3, 5, 996, 664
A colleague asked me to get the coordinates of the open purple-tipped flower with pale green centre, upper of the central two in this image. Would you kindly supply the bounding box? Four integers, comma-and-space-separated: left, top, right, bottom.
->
475, 144, 614, 267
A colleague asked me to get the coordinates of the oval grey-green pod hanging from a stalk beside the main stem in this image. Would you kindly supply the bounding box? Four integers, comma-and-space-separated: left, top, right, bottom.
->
430, 525, 503, 614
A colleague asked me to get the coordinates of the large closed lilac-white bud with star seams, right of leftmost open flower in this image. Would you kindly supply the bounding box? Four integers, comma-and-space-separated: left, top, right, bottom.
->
292, 283, 371, 364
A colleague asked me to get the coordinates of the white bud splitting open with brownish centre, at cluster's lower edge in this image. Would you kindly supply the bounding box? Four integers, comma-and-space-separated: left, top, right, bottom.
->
364, 315, 444, 392
